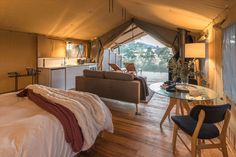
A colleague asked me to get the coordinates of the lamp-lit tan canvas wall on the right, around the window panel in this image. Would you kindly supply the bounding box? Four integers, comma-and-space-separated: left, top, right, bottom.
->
200, 2, 236, 152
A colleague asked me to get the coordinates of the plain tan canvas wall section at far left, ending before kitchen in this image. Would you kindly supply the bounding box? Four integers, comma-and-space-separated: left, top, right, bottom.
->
0, 30, 37, 93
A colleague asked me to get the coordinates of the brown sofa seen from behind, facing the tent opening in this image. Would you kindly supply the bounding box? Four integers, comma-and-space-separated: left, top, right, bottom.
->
76, 70, 140, 114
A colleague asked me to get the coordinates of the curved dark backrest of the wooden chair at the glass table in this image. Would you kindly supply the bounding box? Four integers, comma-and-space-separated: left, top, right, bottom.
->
190, 104, 231, 123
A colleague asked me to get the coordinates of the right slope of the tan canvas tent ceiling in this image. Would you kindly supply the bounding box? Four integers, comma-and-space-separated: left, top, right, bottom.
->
119, 0, 235, 31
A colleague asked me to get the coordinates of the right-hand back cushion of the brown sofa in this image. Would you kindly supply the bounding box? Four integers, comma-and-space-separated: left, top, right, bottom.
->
104, 71, 134, 81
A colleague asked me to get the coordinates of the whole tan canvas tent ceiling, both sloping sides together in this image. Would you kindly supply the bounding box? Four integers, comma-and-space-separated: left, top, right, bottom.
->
0, 0, 234, 40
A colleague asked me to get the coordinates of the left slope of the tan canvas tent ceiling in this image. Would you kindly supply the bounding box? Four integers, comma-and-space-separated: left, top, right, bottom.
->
0, 0, 131, 40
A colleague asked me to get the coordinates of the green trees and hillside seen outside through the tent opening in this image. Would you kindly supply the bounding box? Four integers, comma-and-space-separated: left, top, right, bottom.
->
120, 42, 173, 72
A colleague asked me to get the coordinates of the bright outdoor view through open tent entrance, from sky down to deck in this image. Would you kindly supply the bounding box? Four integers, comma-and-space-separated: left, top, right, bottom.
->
120, 35, 173, 84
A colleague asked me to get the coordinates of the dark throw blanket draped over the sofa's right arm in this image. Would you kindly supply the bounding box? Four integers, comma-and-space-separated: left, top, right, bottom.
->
134, 76, 149, 100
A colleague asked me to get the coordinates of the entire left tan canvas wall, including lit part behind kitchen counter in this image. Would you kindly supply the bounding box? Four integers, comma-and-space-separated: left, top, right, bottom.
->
0, 30, 89, 93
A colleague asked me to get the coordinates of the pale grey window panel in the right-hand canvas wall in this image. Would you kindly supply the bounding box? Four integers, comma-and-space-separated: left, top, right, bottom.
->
223, 24, 236, 102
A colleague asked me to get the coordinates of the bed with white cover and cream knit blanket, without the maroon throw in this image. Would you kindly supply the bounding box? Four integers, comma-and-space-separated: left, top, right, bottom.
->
0, 85, 113, 157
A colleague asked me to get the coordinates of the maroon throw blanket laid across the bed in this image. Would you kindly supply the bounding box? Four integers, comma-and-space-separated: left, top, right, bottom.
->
17, 89, 84, 152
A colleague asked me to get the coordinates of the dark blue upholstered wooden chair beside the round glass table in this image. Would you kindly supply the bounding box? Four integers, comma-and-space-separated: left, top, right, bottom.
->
171, 104, 231, 157
